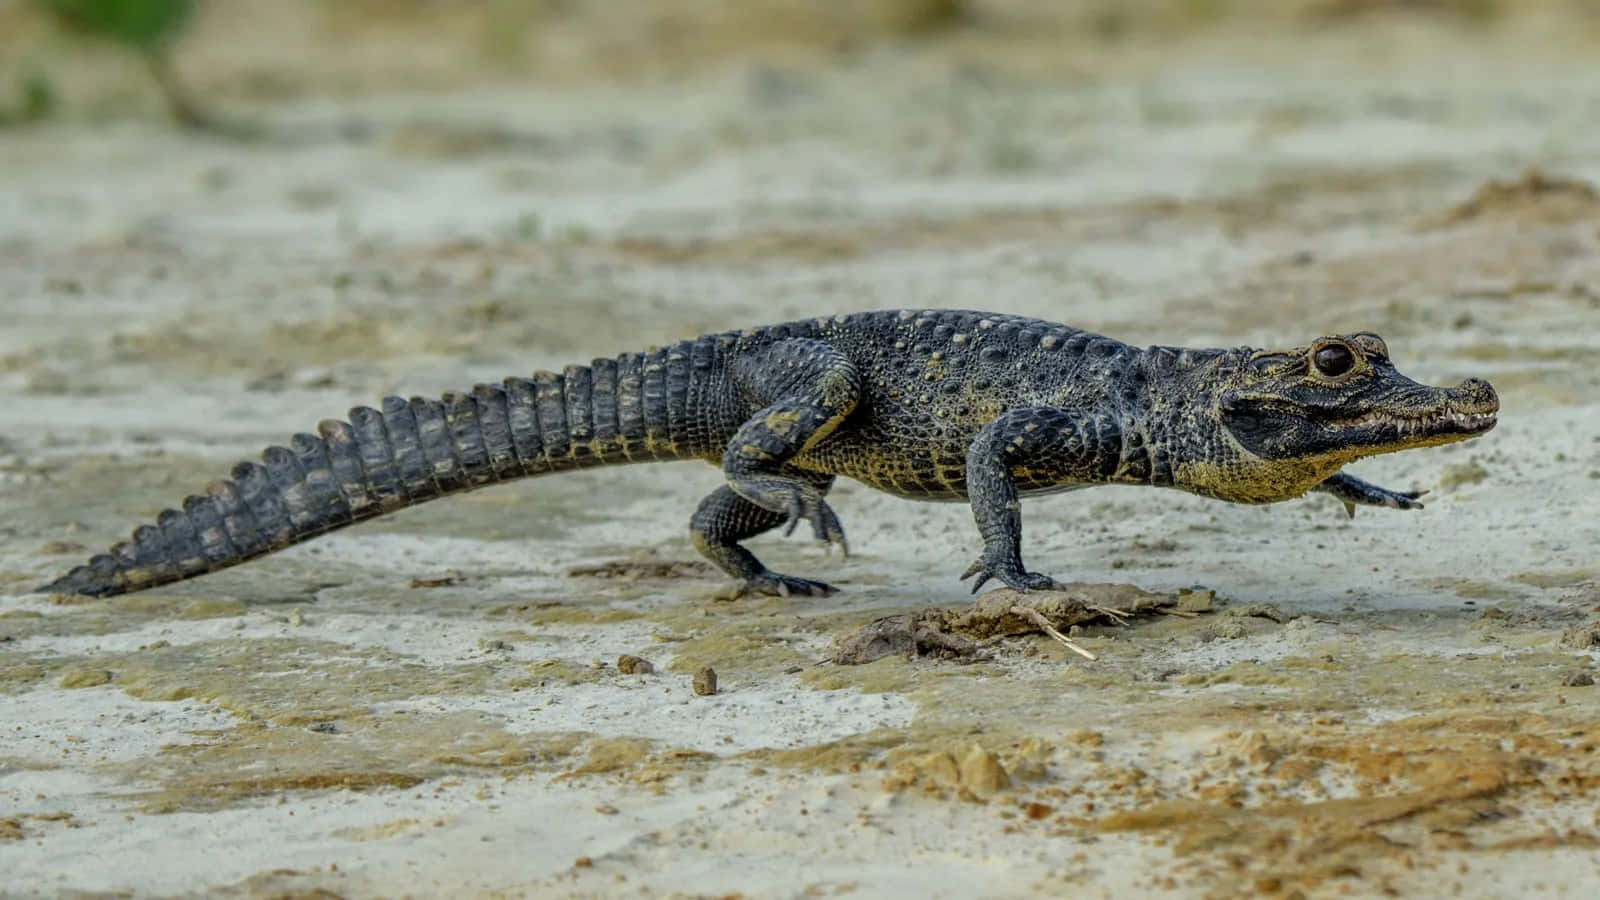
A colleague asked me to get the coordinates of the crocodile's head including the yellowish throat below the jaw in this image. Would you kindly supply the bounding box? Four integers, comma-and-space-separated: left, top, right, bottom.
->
1179, 331, 1499, 503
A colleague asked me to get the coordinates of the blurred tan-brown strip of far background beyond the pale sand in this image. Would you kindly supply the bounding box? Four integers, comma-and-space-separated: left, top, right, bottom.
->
0, 0, 1600, 104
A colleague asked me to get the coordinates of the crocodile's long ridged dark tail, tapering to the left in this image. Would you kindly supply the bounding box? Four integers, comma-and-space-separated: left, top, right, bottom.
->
38, 344, 717, 596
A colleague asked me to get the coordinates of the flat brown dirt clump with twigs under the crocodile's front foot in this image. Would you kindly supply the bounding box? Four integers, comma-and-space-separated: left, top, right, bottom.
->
832, 585, 1210, 666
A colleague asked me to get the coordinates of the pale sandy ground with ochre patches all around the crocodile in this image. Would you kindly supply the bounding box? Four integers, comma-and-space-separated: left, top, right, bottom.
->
0, 8, 1600, 897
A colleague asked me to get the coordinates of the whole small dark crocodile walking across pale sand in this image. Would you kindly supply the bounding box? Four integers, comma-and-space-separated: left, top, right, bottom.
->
40, 309, 1499, 596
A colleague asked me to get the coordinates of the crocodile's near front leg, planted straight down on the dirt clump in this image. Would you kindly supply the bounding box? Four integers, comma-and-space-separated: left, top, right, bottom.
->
962, 407, 1122, 594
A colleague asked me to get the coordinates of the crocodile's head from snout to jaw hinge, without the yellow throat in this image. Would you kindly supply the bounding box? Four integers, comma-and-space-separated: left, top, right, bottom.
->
1218, 331, 1499, 464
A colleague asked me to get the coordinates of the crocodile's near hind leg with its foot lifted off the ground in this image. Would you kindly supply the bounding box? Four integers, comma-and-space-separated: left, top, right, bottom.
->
714, 338, 861, 552
